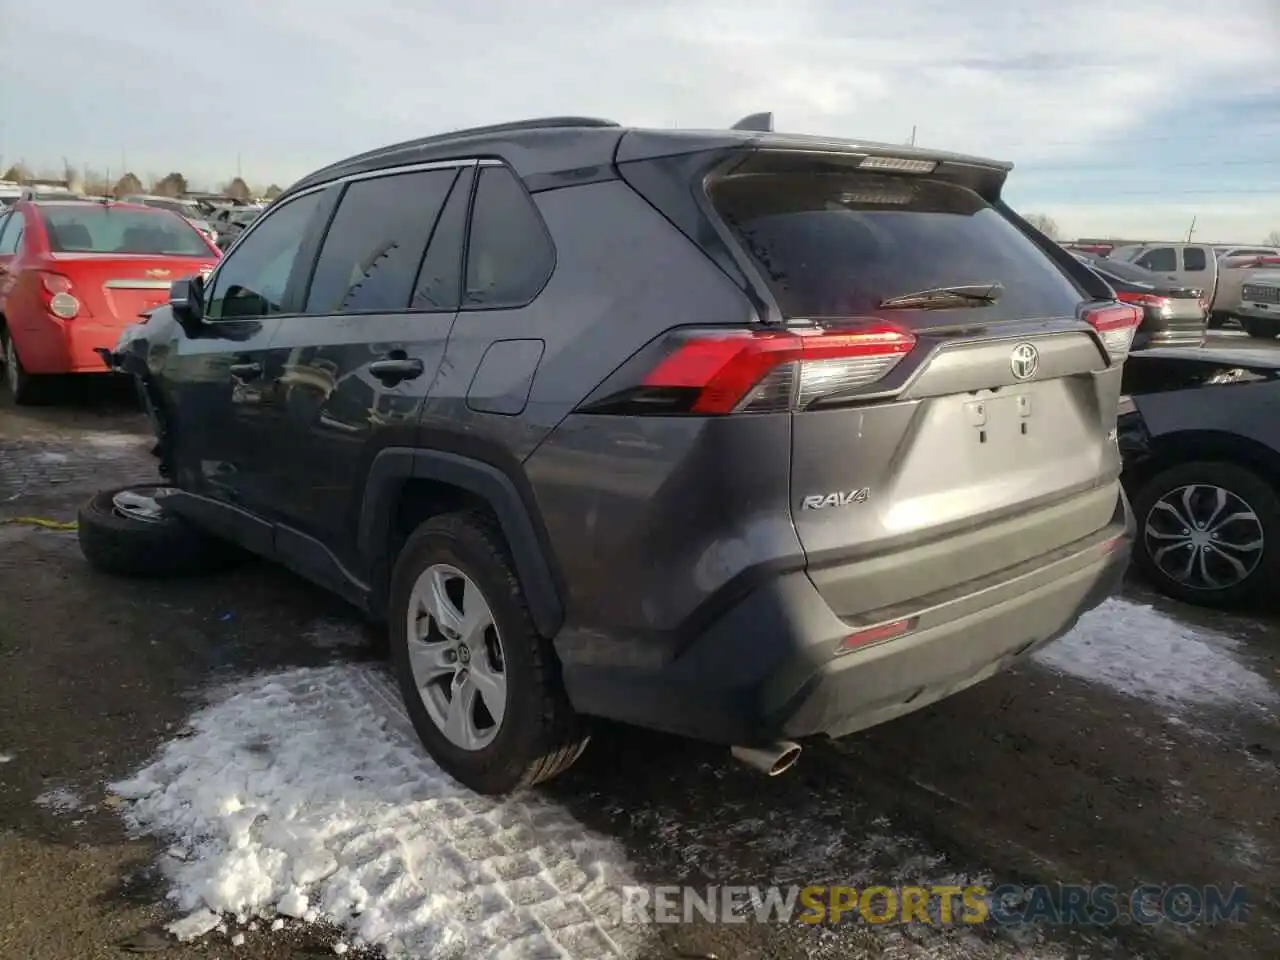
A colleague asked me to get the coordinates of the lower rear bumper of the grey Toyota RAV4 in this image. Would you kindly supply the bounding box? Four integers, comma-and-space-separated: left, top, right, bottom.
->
562, 494, 1133, 745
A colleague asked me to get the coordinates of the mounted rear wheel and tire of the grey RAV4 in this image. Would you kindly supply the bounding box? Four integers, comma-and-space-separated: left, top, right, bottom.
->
389, 512, 588, 795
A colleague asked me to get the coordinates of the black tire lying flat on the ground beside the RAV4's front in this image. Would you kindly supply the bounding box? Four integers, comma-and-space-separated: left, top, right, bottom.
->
77, 484, 243, 577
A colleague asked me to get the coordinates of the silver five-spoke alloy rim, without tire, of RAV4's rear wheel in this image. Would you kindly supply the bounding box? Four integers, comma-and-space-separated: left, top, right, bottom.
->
407, 563, 507, 751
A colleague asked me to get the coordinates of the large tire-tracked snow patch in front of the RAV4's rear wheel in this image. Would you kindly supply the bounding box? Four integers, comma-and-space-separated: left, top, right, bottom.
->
113, 666, 639, 960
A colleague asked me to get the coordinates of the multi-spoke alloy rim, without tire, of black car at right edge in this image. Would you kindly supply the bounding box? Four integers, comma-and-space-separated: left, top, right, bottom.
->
1143, 484, 1266, 590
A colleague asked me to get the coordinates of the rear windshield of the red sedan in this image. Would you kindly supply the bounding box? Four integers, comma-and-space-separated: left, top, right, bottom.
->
41, 205, 211, 257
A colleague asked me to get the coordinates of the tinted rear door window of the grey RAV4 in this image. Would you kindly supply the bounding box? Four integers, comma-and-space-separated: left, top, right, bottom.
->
306, 170, 458, 314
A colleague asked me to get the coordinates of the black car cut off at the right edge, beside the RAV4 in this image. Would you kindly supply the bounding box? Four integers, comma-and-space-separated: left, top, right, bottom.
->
1117, 349, 1280, 605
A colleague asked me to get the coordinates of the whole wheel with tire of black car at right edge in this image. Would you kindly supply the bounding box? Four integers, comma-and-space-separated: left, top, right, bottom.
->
1134, 462, 1280, 607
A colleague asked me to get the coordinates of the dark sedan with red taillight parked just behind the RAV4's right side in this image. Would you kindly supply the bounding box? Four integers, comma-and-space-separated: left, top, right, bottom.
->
1080, 255, 1208, 349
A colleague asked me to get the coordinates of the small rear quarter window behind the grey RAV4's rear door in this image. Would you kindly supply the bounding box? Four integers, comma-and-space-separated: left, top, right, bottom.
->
462, 166, 556, 310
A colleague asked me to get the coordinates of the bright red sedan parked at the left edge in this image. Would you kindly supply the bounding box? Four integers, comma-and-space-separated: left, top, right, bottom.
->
0, 200, 220, 403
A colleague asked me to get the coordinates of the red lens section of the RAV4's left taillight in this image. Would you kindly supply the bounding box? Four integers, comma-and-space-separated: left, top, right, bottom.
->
641, 321, 915, 413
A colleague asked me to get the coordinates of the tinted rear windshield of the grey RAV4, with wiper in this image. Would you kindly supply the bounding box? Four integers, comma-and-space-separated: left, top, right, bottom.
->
710, 173, 1082, 319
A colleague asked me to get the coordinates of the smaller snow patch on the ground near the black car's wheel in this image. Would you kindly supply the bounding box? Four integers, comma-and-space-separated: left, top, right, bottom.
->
1034, 598, 1276, 708
